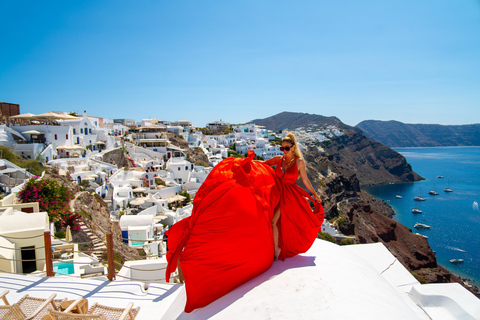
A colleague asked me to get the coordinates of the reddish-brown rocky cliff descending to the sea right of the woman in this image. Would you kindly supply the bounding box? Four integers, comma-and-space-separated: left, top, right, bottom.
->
304, 148, 478, 295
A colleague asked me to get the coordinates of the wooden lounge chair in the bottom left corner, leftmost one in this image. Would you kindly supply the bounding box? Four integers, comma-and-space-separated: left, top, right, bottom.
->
0, 290, 66, 320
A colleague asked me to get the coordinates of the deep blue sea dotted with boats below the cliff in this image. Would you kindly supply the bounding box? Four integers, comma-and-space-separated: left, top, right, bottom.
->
366, 147, 480, 286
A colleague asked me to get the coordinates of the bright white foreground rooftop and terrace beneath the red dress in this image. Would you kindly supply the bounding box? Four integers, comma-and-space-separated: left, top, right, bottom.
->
0, 240, 480, 320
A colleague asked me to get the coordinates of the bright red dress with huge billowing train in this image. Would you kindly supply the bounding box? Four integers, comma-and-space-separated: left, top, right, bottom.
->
166, 152, 323, 312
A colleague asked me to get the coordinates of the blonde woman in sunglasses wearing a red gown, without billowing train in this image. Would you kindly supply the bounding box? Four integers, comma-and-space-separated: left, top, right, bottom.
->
264, 133, 323, 260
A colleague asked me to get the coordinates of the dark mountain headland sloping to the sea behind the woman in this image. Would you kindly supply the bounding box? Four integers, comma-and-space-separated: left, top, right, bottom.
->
250, 112, 423, 185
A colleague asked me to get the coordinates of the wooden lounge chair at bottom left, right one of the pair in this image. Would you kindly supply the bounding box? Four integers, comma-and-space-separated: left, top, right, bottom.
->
49, 297, 140, 320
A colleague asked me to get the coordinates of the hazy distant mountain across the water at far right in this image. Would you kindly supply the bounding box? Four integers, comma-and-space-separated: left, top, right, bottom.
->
356, 120, 480, 148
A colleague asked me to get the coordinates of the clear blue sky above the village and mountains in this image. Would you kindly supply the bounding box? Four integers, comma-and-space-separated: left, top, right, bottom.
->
0, 0, 480, 126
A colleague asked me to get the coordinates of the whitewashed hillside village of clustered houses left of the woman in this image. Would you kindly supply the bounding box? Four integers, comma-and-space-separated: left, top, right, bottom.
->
0, 107, 348, 273
